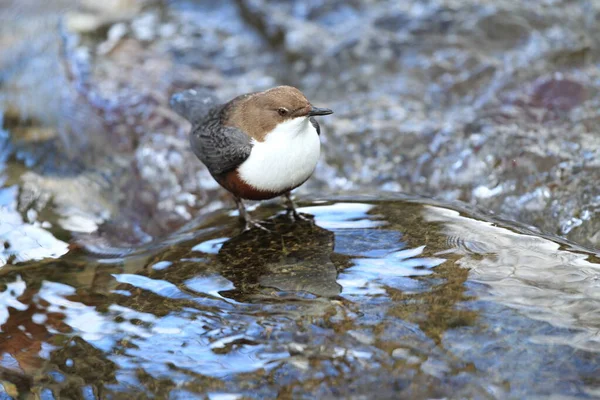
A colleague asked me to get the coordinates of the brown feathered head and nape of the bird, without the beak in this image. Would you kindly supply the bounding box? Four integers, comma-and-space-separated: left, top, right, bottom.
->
222, 86, 311, 142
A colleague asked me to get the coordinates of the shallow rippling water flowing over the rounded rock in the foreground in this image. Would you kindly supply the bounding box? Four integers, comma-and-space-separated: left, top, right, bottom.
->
0, 198, 600, 398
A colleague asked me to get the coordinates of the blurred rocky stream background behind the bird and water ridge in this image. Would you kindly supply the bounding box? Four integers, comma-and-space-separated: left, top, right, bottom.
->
0, 0, 600, 263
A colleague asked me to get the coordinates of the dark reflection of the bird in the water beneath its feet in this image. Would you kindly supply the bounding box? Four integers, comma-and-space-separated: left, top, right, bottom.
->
218, 215, 342, 301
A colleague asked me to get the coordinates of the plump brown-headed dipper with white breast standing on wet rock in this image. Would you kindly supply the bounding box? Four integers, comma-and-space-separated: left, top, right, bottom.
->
171, 86, 333, 229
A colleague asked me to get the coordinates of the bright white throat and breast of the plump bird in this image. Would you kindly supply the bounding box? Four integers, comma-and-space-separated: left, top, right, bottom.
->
238, 117, 321, 192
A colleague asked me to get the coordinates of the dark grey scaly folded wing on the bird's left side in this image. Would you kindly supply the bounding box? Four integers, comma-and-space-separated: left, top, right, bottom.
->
190, 122, 252, 175
